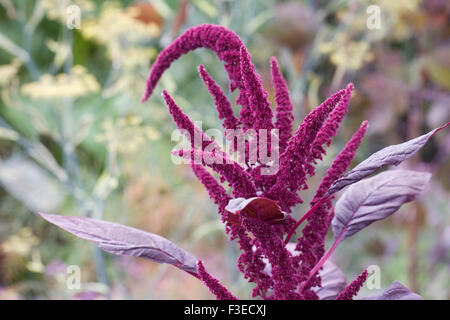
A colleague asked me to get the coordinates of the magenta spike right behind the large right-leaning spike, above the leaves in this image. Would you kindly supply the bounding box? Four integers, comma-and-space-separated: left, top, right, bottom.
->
307, 83, 353, 176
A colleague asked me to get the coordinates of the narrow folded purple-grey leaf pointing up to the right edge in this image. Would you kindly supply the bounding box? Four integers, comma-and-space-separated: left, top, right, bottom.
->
325, 123, 450, 195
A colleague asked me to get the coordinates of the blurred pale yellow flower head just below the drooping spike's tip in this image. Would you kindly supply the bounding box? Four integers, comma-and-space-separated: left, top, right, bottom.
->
96, 115, 159, 153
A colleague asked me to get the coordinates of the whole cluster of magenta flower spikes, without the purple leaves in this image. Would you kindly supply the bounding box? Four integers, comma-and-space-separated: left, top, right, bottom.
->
142, 25, 367, 299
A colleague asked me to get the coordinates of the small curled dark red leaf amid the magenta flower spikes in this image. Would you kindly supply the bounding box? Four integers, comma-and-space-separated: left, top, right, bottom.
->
225, 197, 285, 224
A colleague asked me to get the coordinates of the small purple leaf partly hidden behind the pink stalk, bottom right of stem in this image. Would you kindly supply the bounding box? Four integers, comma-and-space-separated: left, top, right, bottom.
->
313, 260, 347, 300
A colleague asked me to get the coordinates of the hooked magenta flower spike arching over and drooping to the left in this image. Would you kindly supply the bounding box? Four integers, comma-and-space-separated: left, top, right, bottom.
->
142, 24, 244, 102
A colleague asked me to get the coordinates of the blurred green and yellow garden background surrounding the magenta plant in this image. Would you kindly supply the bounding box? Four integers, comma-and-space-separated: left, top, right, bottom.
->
0, 0, 450, 299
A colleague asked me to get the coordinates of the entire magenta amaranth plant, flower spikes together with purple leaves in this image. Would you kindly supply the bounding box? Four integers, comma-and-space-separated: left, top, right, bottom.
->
41, 24, 442, 300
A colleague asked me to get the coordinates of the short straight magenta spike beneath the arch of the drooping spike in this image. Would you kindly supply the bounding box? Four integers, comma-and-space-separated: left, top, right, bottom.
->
198, 65, 239, 129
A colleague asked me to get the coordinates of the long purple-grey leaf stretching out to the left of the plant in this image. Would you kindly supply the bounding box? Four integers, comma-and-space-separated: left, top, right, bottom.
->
39, 213, 197, 276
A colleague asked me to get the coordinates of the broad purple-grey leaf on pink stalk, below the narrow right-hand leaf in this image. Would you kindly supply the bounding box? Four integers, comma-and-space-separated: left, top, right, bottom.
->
332, 170, 431, 242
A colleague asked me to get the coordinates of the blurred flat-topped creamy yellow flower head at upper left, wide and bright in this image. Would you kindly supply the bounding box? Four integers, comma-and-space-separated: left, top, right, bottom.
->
21, 66, 100, 99
